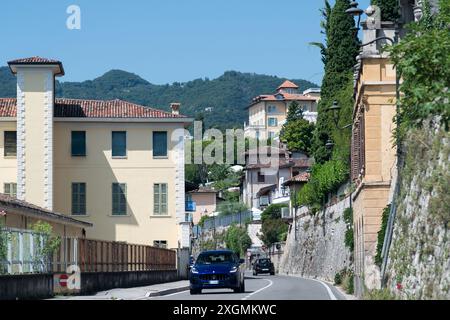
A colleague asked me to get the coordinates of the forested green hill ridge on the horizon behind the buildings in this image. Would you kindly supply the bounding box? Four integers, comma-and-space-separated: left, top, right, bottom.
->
0, 67, 317, 128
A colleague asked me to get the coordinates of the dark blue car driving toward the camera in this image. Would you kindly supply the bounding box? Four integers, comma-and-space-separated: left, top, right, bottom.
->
189, 250, 245, 295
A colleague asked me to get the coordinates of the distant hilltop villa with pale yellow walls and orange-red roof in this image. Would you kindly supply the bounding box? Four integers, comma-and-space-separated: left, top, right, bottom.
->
244, 81, 320, 139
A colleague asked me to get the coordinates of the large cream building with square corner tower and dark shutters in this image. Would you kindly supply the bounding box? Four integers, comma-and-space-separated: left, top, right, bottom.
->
0, 57, 192, 248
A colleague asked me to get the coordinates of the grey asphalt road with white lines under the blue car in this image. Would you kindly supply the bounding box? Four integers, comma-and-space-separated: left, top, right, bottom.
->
149, 273, 345, 301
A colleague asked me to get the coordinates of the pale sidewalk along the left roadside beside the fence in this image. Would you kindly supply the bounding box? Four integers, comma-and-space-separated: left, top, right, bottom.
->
51, 280, 189, 300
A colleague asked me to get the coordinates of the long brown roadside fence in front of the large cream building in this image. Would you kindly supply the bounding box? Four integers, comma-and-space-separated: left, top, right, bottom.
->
0, 228, 177, 275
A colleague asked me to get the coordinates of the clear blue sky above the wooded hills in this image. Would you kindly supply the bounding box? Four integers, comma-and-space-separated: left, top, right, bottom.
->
0, 0, 369, 84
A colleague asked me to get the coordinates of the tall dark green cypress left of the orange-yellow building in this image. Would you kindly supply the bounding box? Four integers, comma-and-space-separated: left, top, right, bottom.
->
313, 0, 360, 163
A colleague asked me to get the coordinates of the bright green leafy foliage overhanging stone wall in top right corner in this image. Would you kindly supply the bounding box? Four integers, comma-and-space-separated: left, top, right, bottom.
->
388, 0, 450, 138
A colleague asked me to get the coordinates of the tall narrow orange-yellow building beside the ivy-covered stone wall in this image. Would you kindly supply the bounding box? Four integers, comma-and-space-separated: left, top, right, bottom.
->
352, 22, 397, 296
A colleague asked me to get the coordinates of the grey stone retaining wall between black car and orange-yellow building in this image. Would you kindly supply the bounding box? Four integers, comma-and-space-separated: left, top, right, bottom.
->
279, 198, 352, 281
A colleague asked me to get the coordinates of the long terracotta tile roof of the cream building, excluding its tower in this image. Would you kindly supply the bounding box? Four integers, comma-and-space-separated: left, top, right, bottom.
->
0, 98, 186, 119
